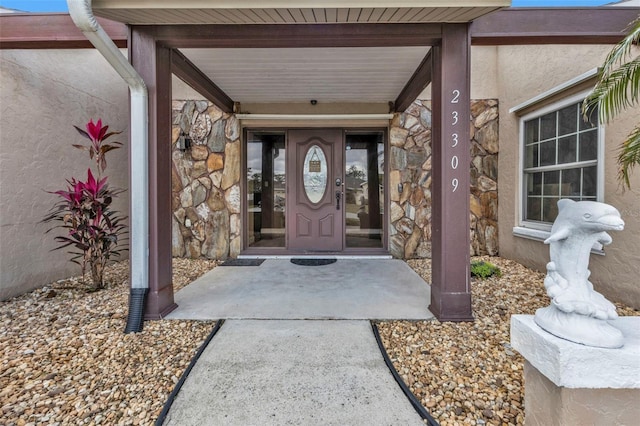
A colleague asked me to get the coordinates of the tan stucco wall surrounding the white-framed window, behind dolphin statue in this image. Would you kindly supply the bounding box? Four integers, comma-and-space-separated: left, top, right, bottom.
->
497, 45, 640, 308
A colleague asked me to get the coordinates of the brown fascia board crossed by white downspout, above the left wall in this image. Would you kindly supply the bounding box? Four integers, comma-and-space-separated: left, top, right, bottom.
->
0, 13, 127, 49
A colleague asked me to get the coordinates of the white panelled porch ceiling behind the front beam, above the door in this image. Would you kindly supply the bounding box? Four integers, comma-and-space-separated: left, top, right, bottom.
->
180, 47, 429, 103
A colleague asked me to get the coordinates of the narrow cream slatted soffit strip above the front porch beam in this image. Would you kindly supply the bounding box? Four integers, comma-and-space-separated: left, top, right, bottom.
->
93, 0, 511, 24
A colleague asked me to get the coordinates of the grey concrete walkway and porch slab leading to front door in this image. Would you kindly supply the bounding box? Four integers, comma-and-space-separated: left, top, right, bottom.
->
163, 259, 433, 426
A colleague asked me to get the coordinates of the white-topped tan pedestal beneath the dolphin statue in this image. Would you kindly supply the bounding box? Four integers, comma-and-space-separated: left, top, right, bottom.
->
511, 315, 640, 426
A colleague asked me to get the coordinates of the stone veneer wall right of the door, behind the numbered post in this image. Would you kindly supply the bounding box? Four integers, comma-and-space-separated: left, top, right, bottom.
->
389, 99, 498, 259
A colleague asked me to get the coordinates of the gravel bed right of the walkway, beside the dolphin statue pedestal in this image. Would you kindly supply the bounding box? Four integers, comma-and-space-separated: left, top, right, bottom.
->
378, 257, 640, 426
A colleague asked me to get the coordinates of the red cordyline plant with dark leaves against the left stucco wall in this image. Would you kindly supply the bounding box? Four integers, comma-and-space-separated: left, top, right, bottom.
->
43, 120, 126, 290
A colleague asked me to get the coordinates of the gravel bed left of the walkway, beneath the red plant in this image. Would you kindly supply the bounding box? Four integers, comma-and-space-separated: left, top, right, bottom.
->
0, 259, 216, 425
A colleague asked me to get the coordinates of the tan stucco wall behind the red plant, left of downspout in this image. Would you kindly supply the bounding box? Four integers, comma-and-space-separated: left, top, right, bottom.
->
0, 50, 129, 299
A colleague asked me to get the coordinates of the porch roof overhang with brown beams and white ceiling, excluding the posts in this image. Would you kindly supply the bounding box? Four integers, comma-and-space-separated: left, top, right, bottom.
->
93, 0, 511, 113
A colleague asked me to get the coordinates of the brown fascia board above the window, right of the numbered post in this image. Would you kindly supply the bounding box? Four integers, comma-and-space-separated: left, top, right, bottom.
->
471, 7, 640, 46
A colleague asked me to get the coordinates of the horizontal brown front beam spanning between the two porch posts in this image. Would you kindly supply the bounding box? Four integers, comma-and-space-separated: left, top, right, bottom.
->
142, 24, 442, 48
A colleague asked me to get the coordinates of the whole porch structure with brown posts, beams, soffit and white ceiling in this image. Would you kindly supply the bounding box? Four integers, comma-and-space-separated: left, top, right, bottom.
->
82, 0, 510, 321
